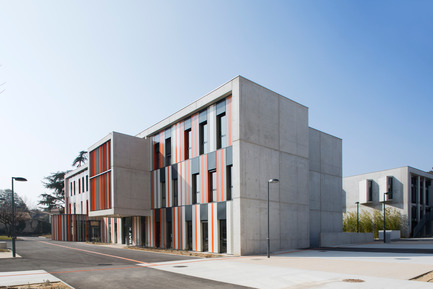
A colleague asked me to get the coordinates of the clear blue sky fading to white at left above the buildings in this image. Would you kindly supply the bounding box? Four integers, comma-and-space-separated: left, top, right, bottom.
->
0, 0, 433, 205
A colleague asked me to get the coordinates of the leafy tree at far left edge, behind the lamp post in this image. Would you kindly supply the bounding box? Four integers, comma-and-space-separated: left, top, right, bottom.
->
0, 190, 30, 236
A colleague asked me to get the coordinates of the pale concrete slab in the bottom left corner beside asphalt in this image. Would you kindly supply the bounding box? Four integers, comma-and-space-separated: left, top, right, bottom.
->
0, 270, 62, 286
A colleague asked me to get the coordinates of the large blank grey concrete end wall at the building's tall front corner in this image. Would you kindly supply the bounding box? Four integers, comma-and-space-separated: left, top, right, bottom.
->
233, 78, 309, 255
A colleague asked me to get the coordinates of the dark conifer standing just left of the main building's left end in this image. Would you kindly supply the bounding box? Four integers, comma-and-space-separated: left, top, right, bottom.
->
38, 172, 67, 212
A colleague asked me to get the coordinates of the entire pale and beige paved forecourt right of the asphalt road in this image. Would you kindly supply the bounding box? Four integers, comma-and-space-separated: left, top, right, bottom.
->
1, 239, 433, 289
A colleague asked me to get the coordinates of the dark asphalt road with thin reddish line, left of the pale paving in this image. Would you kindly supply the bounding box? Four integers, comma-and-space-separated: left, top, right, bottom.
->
0, 237, 247, 289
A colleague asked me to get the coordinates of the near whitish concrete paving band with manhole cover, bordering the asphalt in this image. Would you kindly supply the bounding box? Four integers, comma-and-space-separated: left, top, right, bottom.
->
153, 258, 433, 289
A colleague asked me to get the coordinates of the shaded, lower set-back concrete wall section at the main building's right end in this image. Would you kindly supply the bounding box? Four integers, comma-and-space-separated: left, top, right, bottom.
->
309, 128, 343, 247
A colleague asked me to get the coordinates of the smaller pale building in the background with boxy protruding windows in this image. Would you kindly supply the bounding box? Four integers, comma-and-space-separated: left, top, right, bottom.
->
343, 167, 433, 237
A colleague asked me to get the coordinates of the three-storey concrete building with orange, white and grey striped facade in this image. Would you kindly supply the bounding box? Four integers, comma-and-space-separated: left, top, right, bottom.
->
52, 76, 356, 255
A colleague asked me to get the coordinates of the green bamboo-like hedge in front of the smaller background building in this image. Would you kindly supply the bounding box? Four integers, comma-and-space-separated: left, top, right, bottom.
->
343, 208, 403, 238
